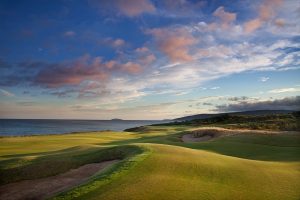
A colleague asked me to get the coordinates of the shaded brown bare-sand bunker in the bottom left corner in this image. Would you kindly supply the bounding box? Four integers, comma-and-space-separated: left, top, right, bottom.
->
0, 160, 118, 200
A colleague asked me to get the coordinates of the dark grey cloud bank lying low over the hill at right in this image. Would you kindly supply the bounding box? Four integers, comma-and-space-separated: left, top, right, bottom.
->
216, 96, 300, 112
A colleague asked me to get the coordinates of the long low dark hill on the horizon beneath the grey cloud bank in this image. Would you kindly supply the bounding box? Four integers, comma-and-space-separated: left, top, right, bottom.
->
173, 110, 294, 121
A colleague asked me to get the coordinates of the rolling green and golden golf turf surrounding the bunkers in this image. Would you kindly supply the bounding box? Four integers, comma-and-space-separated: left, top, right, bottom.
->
0, 125, 300, 199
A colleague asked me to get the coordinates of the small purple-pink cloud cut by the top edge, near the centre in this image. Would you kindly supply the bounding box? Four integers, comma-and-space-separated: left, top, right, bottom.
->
89, 0, 156, 17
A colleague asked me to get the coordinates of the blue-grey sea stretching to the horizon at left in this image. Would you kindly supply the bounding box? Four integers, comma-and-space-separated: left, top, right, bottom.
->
0, 119, 162, 136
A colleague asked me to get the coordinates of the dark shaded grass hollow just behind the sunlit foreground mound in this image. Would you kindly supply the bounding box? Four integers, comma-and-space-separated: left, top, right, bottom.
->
103, 132, 300, 161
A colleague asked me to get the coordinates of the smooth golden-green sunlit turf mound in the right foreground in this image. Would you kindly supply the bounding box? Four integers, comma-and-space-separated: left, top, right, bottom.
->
53, 144, 300, 200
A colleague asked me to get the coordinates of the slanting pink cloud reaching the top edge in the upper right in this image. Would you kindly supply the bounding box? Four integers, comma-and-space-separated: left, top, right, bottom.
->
244, 0, 283, 34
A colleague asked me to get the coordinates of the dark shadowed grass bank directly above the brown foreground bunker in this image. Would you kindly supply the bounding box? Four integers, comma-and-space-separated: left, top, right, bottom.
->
0, 145, 141, 185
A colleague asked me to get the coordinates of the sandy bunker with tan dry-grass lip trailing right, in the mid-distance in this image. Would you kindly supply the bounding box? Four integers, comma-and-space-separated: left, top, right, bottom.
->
181, 127, 295, 143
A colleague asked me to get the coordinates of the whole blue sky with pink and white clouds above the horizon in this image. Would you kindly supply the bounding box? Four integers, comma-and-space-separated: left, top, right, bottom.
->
0, 0, 300, 120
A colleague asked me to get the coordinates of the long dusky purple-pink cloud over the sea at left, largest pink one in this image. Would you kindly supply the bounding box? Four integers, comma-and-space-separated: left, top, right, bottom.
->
33, 55, 146, 88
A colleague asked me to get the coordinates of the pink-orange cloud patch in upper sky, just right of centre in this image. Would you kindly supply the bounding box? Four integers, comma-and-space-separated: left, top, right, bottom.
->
147, 28, 198, 62
